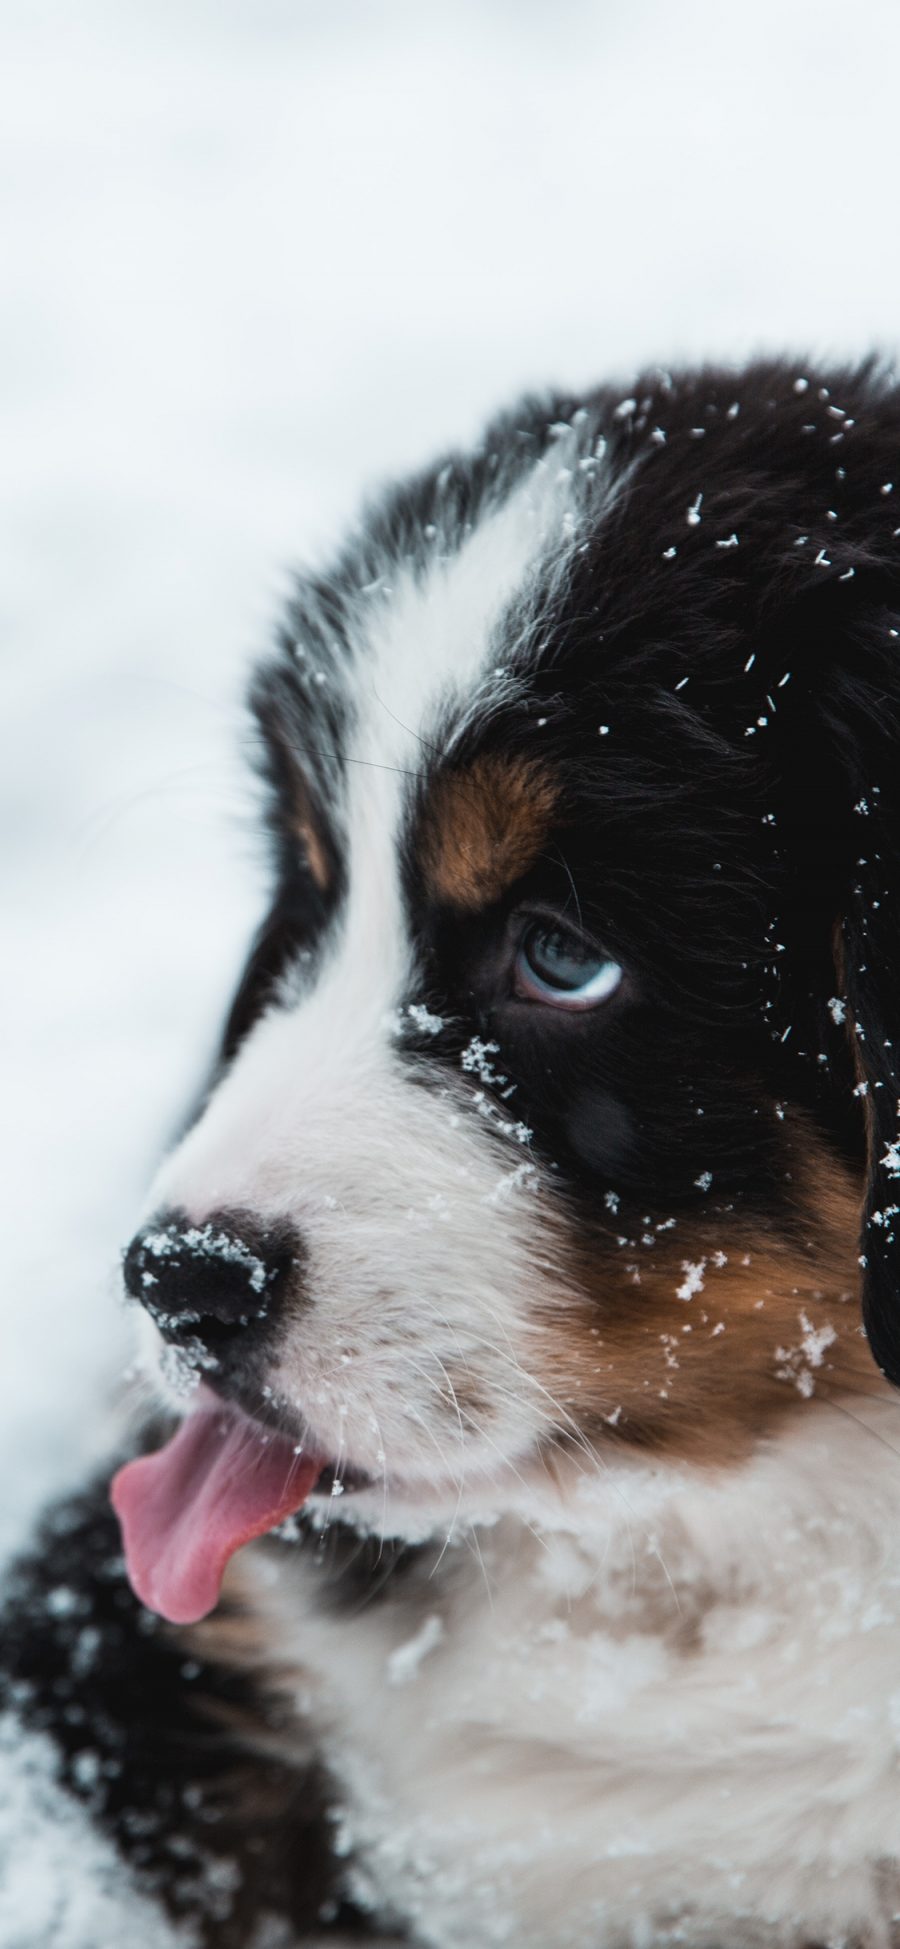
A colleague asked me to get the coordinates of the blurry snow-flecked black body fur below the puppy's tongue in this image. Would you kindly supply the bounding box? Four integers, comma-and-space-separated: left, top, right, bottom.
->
0, 1479, 383, 1949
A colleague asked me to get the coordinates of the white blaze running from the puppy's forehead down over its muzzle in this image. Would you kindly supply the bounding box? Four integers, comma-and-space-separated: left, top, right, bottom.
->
152, 448, 588, 1481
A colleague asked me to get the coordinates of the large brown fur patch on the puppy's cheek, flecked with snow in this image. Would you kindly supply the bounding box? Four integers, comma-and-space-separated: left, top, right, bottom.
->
538, 1156, 886, 1464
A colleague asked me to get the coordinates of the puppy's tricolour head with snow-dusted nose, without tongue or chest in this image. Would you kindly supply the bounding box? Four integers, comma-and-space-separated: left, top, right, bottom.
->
129, 368, 900, 1524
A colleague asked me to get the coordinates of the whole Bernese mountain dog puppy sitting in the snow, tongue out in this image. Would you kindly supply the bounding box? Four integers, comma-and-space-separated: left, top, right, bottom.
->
4, 363, 900, 1949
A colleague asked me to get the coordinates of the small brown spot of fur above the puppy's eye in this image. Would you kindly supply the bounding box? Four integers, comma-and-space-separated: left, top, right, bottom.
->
421, 754, 557, 912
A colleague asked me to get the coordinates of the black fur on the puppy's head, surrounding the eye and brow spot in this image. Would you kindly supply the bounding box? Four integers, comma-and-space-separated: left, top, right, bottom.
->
244, 363, 900, 1378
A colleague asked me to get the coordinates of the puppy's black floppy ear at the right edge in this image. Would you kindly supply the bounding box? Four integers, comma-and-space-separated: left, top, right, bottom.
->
758, 536, 900, 1386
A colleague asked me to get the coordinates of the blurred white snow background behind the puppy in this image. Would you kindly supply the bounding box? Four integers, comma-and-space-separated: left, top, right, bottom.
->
0, 0, 900, 1949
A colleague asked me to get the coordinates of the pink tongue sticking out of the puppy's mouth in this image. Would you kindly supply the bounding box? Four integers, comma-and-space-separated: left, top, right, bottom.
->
111, 1394, 323, 1624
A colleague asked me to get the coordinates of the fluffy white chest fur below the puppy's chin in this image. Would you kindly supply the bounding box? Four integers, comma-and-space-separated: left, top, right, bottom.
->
247, 1399, 900, 1949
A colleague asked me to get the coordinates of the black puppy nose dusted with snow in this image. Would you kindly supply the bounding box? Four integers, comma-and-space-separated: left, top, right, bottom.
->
123, 1210, 300, 1345
